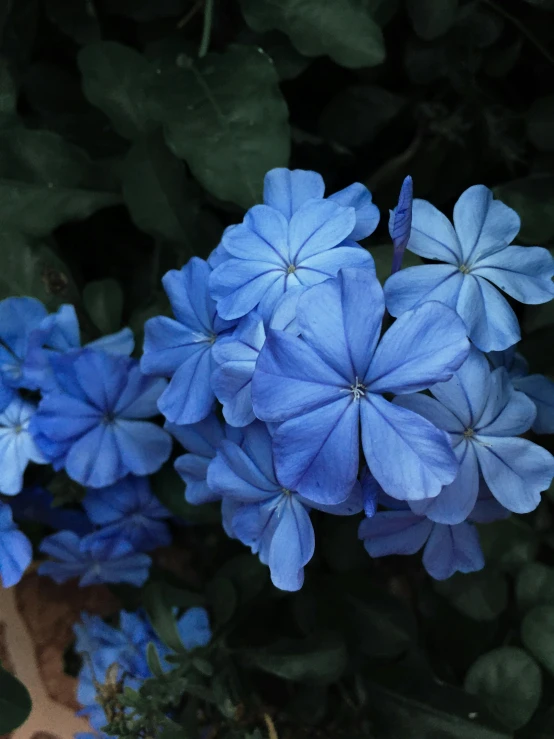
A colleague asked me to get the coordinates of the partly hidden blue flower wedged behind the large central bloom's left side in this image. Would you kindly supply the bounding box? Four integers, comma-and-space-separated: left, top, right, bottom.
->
212, 287, 304, 427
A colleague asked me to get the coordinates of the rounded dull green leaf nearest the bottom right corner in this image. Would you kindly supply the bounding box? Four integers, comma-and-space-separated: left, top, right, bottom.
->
464, 647, 542, 729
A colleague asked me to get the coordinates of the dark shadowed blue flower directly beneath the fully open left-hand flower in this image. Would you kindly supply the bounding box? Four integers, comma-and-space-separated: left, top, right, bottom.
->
83, 475, 171, 552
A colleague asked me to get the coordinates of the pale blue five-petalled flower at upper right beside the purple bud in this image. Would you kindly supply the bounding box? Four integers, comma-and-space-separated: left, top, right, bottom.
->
385, 185, 554, 351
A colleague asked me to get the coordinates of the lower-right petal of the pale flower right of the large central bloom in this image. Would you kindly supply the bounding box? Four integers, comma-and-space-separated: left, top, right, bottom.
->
475, 436, 554, 513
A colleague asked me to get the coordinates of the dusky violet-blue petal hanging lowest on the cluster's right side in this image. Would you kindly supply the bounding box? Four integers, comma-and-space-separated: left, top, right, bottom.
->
423, 523, 485, 580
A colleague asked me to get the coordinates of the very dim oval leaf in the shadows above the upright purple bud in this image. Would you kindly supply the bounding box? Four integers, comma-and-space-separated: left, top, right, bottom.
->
319, 85, 406, 148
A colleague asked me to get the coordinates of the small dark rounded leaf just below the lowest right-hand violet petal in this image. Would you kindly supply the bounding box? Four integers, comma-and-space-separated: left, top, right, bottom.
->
434, 569, 508, 621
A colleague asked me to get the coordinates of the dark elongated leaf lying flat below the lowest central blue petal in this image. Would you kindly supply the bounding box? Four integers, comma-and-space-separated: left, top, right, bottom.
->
246, 632, 346, 685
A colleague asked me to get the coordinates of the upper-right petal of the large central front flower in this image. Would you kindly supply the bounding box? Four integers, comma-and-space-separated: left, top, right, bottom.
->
364, 302, 469, 393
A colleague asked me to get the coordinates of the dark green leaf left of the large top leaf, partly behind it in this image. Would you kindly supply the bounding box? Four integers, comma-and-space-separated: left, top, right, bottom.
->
77, 41, 156, 139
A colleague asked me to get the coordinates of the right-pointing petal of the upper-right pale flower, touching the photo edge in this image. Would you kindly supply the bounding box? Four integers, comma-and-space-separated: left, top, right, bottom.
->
471, 246, 554, 304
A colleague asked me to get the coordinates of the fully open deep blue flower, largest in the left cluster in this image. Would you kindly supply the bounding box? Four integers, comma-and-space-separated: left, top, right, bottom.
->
31, 349, 171, 488
